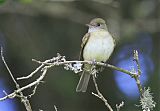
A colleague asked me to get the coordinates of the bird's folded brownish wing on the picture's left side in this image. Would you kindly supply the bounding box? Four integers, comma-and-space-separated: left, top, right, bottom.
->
79, 33, 90, 60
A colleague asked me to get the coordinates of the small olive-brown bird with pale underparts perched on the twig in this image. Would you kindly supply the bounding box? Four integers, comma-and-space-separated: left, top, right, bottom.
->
76, 18, 115, 92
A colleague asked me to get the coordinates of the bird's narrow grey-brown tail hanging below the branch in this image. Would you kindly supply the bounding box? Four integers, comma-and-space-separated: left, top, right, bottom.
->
76, 71, 91, 92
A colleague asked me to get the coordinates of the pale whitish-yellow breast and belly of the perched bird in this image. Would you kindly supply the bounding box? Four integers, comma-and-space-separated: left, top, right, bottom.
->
83, 30, 114, 62
